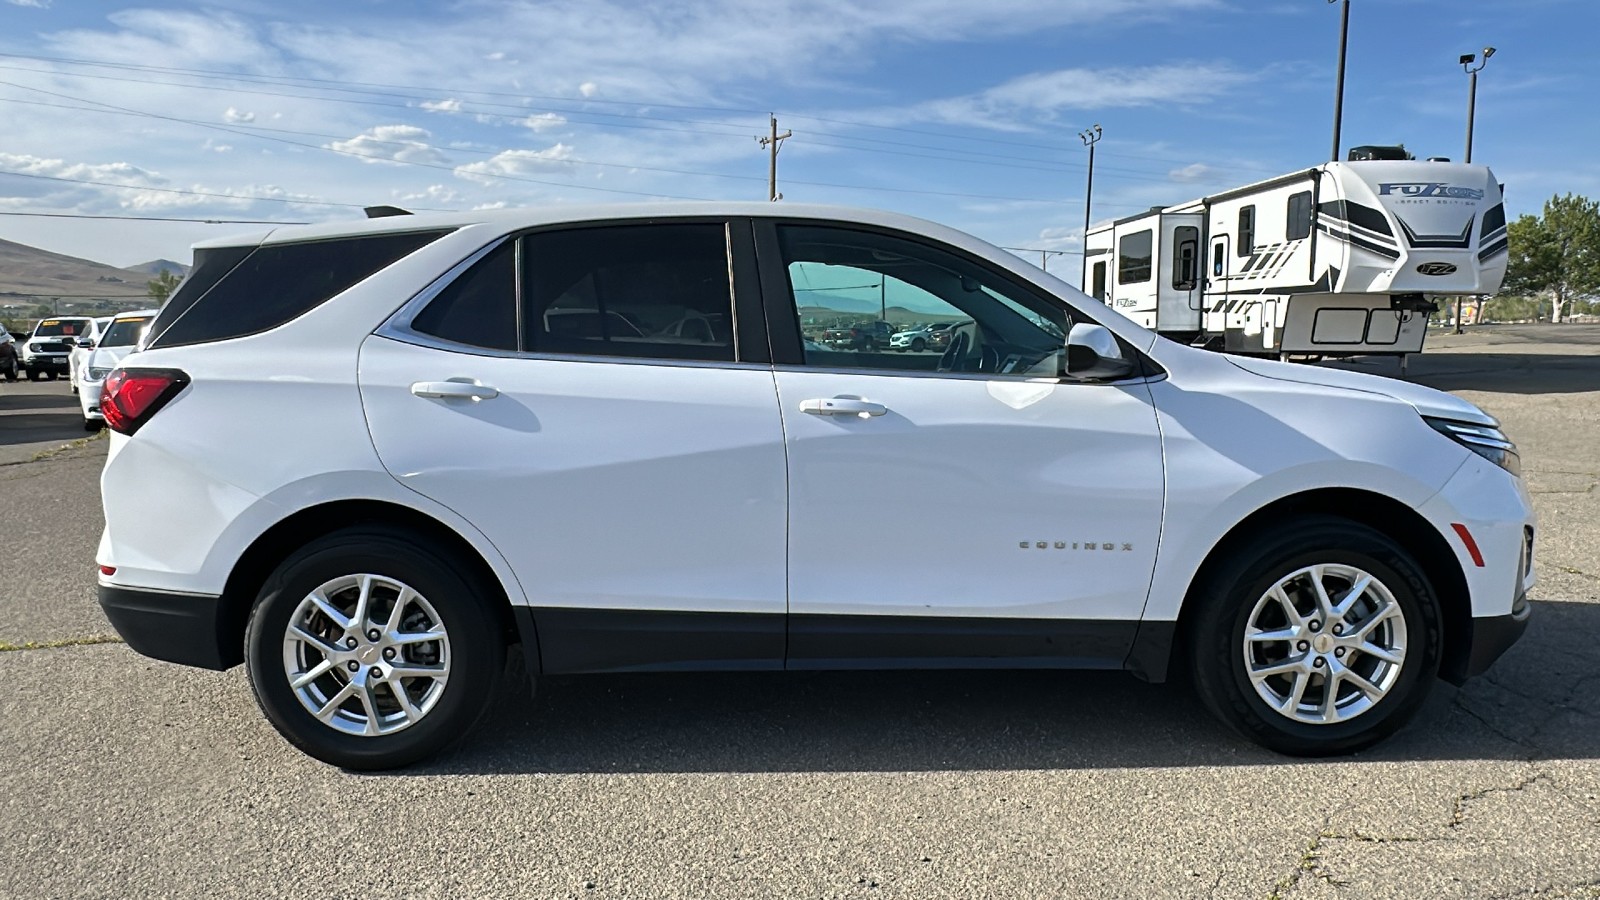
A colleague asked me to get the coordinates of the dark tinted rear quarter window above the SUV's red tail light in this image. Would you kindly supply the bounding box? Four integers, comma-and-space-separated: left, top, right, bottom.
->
150, 231, 448, 348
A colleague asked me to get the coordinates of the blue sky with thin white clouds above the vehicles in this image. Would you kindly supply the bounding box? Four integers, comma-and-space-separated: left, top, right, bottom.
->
0, 0, 1600, 273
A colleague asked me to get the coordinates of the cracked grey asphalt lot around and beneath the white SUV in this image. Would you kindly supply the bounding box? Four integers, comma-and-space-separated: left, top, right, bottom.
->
0, 327, 1600, 900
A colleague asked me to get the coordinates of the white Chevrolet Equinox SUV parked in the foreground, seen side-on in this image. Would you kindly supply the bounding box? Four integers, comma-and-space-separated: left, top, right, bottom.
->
98, 203, 1533, 769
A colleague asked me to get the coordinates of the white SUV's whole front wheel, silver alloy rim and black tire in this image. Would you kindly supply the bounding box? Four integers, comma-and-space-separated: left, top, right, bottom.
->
1189, 517, 1442, 756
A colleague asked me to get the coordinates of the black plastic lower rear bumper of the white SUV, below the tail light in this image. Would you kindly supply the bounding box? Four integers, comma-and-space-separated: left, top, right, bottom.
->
99, 585, 243, 669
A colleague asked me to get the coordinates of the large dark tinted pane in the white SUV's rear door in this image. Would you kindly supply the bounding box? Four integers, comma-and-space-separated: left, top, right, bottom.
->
522, 224, 733, 362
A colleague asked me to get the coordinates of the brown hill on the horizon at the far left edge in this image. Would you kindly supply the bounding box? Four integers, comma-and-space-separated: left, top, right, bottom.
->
0, 240, 165, 317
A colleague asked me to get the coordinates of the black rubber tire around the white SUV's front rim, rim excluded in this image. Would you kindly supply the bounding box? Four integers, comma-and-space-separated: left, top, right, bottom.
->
1189, 516, 1443, 756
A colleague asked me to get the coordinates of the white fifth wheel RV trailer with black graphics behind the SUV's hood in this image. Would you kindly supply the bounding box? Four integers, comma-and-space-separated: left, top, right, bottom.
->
1085, 147, 1507, 360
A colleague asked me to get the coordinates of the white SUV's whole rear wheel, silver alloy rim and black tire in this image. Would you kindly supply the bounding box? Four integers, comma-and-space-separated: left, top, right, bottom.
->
245, 528, 506, 770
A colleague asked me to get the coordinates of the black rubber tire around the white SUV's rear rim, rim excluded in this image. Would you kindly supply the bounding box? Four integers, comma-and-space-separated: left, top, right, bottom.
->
245, 527, 506, 770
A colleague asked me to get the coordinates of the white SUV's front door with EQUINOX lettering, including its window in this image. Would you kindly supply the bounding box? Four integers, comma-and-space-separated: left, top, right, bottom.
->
758, 219, 1163, 668
